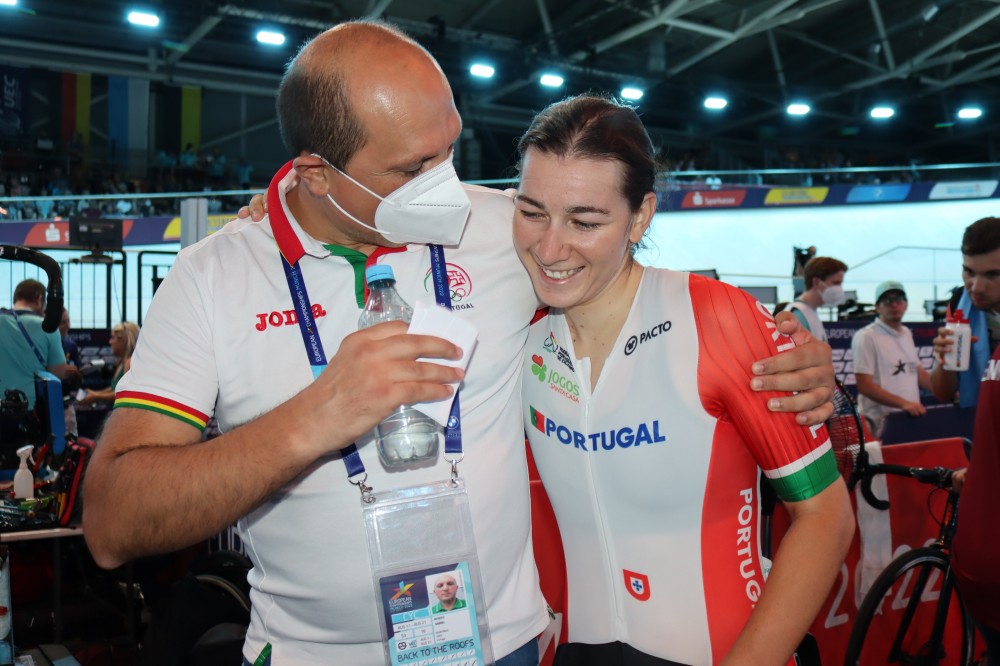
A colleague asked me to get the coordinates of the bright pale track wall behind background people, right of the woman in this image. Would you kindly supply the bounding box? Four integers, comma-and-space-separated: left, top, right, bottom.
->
637, 199, 1000, 320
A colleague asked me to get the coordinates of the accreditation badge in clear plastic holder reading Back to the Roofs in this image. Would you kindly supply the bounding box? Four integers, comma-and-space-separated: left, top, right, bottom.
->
363, 478, 493, 666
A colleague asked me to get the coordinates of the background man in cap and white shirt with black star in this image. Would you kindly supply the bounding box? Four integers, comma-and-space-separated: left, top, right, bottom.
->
851, 280, 931, 435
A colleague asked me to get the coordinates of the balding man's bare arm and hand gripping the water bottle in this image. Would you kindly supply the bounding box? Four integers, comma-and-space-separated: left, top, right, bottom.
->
83, 322, 464, 568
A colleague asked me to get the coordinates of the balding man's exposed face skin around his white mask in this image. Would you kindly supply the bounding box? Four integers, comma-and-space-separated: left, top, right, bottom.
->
328, 62, 462, 245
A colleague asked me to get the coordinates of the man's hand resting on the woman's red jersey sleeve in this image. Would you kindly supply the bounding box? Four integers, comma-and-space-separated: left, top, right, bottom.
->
750, 311, 835, 425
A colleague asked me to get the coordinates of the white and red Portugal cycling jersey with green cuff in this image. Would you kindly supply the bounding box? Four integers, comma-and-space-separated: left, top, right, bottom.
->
523, 268, 838, 664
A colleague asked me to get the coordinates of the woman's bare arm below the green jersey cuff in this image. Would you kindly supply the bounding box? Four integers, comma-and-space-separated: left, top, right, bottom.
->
722, 479, 854, 666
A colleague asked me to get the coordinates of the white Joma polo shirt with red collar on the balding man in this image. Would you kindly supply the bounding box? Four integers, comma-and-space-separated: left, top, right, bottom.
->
116, 164, 547, 666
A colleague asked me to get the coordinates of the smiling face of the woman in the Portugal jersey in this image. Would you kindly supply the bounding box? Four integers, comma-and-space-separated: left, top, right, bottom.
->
514, 148, 656, 309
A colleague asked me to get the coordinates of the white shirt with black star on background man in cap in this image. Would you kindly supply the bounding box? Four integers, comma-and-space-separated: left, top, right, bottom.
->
851, 319, 920, 433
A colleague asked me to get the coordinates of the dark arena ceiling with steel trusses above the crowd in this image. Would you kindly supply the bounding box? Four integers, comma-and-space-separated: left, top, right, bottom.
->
0, 0, 1000, 161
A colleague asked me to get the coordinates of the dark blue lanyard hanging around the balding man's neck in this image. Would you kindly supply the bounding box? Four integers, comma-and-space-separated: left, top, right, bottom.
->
281, 245, 462, 492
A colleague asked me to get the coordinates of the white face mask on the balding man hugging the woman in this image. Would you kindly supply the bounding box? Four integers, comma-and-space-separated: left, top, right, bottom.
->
312, 153, 472, 245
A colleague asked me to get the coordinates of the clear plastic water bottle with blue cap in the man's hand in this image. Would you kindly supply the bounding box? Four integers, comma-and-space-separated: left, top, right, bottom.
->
358, 265, 442, 467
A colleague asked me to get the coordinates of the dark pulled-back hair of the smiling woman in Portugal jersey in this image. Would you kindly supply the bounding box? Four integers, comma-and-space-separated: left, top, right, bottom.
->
517, 94, 657, 211
